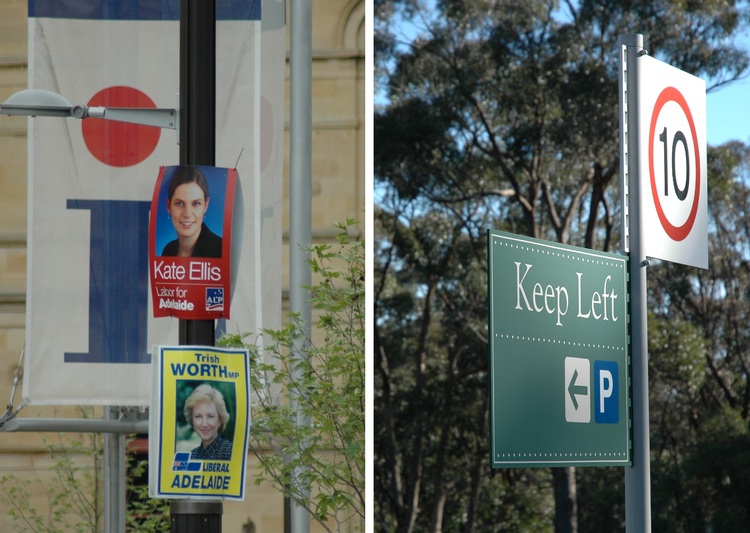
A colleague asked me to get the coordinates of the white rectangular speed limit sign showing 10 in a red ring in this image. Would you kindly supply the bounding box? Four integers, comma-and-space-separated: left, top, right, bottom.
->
638, 55, 708, 268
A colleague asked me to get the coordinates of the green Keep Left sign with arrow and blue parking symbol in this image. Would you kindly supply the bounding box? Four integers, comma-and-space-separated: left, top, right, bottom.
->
488, 230, 631, 468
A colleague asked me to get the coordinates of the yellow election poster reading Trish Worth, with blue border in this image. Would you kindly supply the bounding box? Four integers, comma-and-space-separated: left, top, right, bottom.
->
149, 346, 250, 500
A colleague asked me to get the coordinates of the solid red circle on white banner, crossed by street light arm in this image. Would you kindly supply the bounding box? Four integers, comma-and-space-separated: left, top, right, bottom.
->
81, 85, 161, 167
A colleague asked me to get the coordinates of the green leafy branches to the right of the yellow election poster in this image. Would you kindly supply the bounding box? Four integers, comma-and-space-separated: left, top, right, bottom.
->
221, 220, 365, 530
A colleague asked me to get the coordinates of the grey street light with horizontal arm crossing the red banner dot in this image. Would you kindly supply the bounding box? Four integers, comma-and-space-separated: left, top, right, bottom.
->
0, 89, 180, 130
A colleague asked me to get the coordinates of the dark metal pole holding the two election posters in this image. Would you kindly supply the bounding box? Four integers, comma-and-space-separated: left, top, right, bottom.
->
170, 0, 223, 533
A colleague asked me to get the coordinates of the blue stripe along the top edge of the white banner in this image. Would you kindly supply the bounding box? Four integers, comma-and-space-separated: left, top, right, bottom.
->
29, 0, 261, 20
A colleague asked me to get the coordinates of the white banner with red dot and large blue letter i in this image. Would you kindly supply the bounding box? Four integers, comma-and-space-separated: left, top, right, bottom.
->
24, 0, 285, 405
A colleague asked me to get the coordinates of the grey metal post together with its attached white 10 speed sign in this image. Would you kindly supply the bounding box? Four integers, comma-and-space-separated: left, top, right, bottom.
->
618, 34, 708, 533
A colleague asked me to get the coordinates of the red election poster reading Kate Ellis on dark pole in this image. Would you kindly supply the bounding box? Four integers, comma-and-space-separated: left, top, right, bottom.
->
149, 165, 237, 320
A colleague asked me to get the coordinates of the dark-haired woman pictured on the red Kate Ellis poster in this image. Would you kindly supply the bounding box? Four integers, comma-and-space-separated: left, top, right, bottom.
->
161, 166, 222, 257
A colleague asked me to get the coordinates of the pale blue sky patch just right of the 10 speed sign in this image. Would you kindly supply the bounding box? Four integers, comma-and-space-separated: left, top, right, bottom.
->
706, 73, 750, 146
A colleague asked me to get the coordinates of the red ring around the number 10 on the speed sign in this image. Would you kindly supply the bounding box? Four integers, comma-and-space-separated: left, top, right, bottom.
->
648, 87, 701, 241
